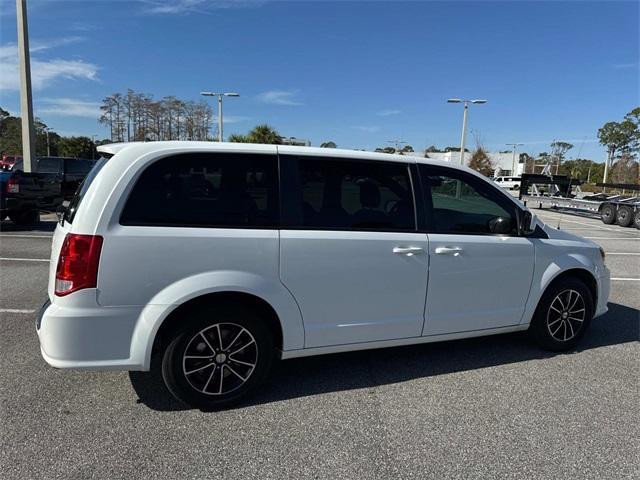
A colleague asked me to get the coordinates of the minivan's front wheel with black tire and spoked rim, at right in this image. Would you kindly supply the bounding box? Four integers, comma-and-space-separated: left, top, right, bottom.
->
529, 277, 594, 352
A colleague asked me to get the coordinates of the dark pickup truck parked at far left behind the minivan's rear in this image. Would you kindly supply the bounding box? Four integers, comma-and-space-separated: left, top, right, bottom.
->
0, 157, 95, 224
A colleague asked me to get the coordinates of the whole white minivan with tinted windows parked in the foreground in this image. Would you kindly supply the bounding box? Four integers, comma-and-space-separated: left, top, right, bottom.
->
36, 142, 609, 409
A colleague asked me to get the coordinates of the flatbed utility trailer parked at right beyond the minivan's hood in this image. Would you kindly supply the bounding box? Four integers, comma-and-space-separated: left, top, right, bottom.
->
519, 173, 640, 229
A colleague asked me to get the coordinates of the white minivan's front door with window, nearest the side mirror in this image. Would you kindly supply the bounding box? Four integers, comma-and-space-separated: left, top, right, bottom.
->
420, 166, 534, 335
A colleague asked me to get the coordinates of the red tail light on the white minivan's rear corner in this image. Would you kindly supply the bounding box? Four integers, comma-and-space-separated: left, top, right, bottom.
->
55, 233, 102, 297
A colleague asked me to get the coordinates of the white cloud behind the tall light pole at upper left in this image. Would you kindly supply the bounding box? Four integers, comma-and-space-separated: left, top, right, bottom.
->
0, 37, 98, 90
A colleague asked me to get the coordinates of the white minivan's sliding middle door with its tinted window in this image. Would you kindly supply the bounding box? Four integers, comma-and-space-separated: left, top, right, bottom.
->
280, 155, 428, 348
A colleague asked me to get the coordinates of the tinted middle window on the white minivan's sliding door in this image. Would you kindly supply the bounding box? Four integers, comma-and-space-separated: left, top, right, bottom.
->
287, 157, 415, 230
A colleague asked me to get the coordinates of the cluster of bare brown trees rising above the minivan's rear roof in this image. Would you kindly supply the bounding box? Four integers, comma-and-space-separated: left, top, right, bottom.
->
98, 89, 213, 142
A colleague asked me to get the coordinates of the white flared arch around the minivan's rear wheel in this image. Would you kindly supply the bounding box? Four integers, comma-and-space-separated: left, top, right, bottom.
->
131, 270, 304, 370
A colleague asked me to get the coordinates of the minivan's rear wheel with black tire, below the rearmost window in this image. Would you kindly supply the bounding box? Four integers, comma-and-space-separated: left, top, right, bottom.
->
162, 307, 275, 410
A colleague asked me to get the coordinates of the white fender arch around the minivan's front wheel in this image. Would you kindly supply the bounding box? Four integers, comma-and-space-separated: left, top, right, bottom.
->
520, 251, 597, 324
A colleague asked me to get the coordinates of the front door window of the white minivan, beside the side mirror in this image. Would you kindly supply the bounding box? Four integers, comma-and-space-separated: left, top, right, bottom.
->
420, 166, 517, 234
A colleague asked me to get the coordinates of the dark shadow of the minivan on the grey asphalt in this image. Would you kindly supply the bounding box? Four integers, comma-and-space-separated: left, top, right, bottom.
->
129, 303, 640, 411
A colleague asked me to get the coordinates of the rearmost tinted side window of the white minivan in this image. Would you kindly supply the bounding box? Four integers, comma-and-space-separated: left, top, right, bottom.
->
120, 153, 278, 227
